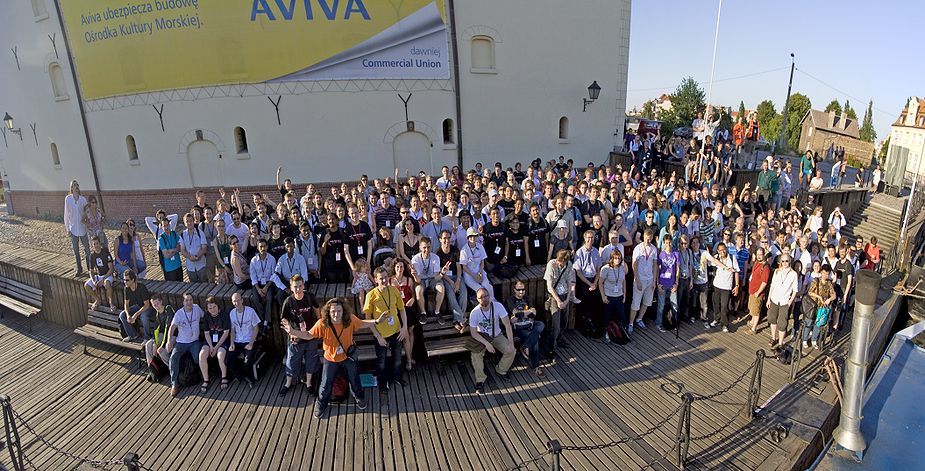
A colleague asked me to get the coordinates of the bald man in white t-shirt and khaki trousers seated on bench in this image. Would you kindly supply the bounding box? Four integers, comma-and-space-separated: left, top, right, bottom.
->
469, 288, 516, 394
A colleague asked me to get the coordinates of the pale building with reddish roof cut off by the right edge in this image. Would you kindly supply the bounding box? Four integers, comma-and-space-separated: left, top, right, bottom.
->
886, 97, 925, 185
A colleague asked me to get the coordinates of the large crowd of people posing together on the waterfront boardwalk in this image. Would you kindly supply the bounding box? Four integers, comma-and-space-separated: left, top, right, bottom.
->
64, 136, 880, 415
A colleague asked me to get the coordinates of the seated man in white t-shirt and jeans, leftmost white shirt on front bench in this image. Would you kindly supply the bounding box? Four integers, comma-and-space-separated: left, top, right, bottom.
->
167, 293, 209, 397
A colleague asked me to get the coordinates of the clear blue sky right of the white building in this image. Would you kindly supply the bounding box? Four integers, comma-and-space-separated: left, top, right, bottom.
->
626, 0, 925, 141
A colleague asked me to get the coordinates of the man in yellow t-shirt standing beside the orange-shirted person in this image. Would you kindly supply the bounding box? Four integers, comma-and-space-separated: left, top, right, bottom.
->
363, 267, 408, 393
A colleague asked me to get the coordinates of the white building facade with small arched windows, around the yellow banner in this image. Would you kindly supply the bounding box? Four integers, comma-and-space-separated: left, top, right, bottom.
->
0, 0, 631, 221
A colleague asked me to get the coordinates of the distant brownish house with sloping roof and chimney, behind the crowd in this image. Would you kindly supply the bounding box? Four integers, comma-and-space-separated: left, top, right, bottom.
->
798, 110, 874, 166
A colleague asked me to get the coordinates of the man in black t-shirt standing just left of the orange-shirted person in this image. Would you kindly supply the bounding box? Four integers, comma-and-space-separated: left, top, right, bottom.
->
279, 275, 321, 396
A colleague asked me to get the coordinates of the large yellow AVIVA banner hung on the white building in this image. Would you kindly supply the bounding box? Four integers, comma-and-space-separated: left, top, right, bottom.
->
61, 0, 449, 100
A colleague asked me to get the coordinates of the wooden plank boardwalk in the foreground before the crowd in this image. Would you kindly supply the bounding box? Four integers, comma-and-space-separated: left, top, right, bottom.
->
0, 304, 847, 470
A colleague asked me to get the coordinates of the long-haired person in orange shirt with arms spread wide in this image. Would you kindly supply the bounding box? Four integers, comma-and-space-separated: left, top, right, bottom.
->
282, 298, 388, 418
